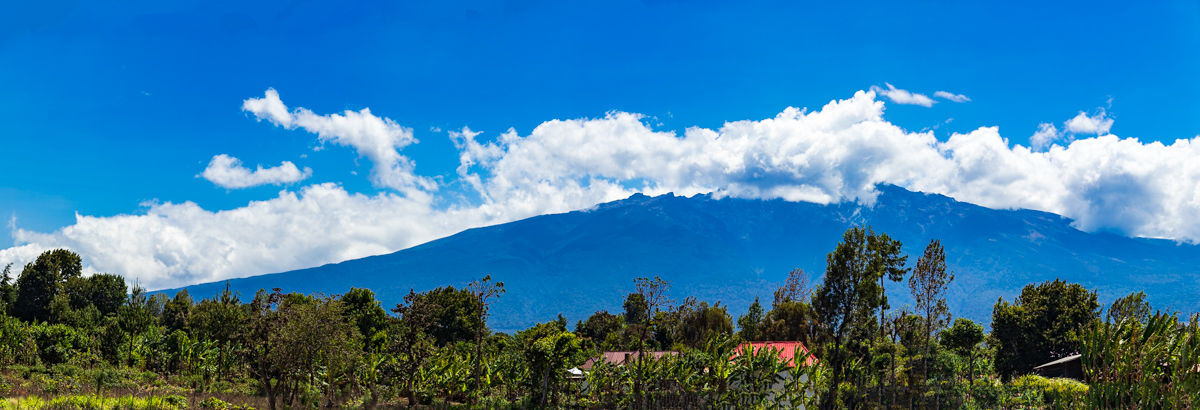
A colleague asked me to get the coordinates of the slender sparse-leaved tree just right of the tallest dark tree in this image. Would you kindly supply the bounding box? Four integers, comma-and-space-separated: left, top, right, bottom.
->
908, 240, 954, 397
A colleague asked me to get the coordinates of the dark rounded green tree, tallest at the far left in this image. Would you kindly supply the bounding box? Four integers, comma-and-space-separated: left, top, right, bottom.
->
13, 249, 83, 321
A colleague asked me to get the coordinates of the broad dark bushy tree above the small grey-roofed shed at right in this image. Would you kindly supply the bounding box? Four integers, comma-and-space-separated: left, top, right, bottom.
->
989, 279, 1100, 380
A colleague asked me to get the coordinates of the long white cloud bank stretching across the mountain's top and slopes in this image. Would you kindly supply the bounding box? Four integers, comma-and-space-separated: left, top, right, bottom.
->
0, 89, 1200, 289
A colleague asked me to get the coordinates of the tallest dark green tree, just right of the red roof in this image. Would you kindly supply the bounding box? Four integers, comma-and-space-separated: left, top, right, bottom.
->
814, 227, 905, 409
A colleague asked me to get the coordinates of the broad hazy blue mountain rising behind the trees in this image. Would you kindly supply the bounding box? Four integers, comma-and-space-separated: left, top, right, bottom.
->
166, 186, 1200, 330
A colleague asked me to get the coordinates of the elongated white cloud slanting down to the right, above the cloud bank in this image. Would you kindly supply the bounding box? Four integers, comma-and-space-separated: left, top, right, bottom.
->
241, 89, 437, 195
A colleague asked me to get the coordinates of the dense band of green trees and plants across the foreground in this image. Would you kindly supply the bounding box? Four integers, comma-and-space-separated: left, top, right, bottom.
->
0, 228, 1200, 410
